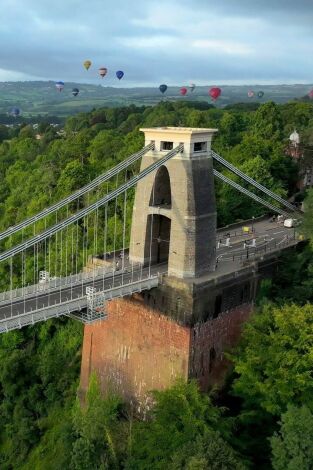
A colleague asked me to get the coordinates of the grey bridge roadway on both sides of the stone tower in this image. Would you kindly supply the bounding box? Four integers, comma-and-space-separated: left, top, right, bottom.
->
0, 219, 297, 332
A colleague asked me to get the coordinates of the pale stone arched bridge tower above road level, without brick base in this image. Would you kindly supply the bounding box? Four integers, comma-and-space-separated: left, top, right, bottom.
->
130, 127, 217, 278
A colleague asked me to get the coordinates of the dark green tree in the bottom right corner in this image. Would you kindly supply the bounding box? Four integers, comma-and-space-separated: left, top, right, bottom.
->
271, 405, 313, 470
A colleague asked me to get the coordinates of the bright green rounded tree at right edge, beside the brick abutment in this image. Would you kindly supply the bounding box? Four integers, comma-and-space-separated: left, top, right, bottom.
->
232, 304, 313, 416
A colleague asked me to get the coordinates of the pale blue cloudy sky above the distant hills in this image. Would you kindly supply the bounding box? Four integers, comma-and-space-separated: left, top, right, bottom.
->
0, 0, 313, 87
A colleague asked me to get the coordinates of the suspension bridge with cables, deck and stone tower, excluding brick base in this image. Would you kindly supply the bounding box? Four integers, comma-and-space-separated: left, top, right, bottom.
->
0, 128, 301, 332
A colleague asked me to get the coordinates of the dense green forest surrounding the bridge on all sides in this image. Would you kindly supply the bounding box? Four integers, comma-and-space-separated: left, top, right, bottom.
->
0, 101, 313, 470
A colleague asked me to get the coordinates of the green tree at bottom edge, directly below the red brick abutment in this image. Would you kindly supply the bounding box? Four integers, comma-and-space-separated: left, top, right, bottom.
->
126, 381, 244, 470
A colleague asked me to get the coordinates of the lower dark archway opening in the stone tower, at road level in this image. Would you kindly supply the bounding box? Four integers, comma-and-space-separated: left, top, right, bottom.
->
145, 214, 171, 264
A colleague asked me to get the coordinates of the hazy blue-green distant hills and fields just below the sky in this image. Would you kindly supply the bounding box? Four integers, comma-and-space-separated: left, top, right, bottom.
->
0, 82, 313, 116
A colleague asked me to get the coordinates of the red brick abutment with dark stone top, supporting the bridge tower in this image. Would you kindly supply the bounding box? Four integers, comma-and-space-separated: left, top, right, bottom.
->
80, 248, 294, 406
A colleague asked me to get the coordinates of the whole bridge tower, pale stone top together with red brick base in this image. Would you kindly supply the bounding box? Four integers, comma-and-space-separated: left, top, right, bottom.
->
81, 127, 260, 403
